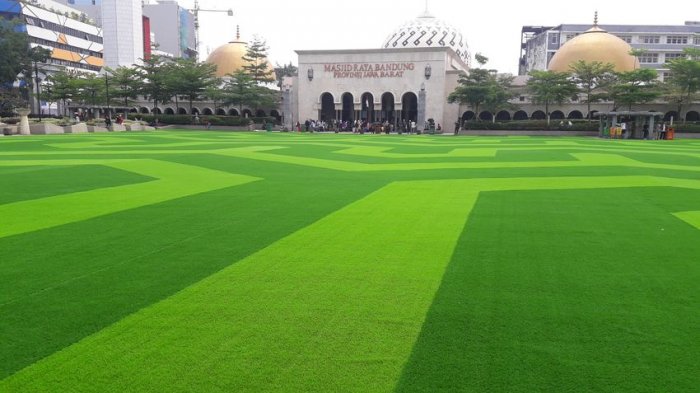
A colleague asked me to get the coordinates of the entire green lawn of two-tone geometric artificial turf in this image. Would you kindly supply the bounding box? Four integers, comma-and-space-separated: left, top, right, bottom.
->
0, 131, 700, 393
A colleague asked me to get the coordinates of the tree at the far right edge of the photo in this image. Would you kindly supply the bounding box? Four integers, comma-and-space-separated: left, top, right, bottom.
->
664, 48, 700, 121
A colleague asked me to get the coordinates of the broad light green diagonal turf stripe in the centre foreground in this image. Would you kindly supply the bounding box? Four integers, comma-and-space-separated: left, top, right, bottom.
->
0, 181, 476, 392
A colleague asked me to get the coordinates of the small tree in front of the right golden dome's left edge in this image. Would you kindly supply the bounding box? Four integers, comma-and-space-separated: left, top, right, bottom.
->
527, 71, 578, 127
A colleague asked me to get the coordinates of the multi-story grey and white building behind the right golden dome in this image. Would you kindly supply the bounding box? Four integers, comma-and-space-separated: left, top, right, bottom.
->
518, 22, 700, 79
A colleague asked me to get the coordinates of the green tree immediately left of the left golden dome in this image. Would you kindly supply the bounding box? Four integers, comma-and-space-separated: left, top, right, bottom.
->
170, 59, 221, 113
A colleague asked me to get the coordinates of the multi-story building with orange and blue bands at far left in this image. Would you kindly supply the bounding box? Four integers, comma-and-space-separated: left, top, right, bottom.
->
0, 0, 104, 72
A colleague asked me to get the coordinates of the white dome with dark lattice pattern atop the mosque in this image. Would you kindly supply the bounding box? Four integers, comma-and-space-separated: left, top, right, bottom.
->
382, 11, 471, 65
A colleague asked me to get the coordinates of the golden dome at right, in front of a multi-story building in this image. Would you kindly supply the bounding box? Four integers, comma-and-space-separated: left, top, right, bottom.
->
548, 24, 639, 72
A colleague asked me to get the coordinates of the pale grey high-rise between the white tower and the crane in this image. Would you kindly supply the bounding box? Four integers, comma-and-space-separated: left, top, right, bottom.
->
143, 0, 197, 59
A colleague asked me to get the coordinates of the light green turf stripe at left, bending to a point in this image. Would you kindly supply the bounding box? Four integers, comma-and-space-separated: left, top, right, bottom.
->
0, 159, 259, 238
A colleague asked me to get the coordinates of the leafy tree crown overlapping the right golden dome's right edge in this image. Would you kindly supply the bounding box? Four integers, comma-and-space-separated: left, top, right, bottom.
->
609, 68, 662, 111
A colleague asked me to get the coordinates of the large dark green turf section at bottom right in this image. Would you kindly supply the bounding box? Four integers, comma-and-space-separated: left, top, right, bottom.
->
396, 188, 700, 392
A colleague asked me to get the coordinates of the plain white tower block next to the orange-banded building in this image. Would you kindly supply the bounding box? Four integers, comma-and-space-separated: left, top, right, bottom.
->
102, 0, 143, 68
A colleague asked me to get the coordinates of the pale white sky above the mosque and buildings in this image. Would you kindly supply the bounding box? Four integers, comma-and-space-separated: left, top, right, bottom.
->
172, 0, 700, 74
